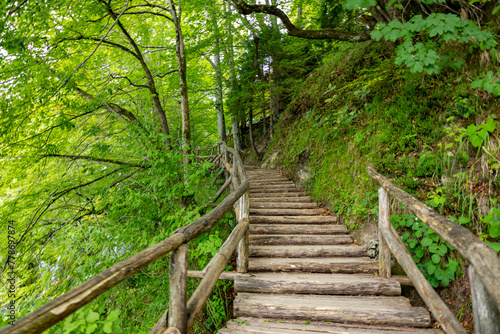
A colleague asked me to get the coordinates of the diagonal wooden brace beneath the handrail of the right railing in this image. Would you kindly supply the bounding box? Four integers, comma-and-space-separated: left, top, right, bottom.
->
382, 225, 466, 334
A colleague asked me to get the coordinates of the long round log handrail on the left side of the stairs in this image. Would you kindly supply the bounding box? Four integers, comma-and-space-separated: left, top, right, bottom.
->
0, 143, 249, 334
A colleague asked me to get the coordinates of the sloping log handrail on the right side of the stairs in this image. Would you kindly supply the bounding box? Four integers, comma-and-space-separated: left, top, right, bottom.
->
367, 167, 500, 309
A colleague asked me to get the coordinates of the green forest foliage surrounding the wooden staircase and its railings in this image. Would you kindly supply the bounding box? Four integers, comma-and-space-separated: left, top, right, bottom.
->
0, 0, 500, 333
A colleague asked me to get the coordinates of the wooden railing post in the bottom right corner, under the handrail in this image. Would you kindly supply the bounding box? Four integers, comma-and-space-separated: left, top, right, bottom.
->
469, 265, 500, 334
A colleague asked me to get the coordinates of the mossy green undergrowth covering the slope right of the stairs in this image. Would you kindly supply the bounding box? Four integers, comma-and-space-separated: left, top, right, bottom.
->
267, 42, 500, 318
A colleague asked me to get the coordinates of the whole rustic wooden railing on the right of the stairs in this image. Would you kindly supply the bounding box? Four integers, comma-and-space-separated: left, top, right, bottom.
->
367, 167, 500, 334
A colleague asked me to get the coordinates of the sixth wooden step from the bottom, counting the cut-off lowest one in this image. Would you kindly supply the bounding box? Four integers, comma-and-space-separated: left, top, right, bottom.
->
248, 234, 353, 245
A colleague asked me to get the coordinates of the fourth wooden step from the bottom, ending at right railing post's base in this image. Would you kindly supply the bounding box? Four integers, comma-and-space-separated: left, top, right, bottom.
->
248, 258, 378, 274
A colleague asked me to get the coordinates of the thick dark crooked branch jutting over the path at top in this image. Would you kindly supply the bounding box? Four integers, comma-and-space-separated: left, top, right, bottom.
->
231, 0, 371, 42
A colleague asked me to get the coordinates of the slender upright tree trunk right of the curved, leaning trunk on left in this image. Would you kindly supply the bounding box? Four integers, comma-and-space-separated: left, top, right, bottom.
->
169, 0, 191, 162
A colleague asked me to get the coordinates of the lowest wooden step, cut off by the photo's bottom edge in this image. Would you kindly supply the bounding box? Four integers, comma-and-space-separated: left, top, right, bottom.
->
217, 317, 444, 334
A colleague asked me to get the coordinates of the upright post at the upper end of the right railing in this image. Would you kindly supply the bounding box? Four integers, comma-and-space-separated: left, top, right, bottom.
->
378, 187, 391, 278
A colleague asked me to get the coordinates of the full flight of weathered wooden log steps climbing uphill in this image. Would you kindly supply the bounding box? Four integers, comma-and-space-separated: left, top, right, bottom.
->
218, 166, 442, 334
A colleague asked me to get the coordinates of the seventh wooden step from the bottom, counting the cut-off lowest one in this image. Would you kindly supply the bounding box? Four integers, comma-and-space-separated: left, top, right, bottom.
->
250, 224, 347, 235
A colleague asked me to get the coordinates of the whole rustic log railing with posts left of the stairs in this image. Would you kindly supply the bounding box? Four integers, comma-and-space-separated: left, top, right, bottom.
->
0, 143, 249, 334
